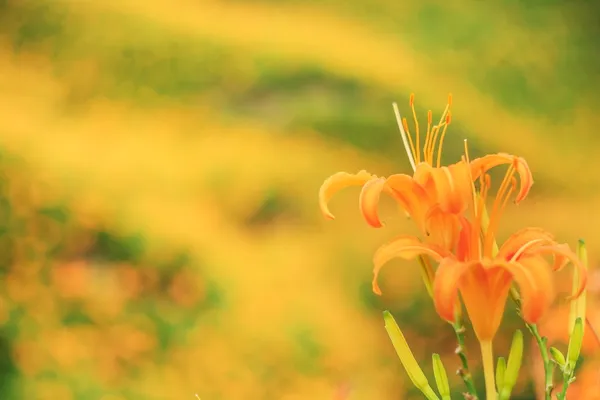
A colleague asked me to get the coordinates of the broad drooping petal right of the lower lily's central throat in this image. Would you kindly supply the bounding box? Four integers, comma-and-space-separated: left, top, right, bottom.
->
503, 256, 554, 324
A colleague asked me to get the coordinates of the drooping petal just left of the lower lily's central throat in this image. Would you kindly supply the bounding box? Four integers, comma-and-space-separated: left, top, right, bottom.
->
433, 258, 477, 322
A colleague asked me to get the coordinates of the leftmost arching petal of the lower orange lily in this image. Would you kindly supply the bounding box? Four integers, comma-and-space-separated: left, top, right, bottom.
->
373, 235, 450, 295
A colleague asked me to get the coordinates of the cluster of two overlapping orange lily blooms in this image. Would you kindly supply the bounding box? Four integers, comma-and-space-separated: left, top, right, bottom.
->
319, 95, 587, 397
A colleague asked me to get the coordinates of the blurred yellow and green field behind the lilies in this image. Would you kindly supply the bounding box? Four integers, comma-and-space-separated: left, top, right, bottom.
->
0, 0, 600, 400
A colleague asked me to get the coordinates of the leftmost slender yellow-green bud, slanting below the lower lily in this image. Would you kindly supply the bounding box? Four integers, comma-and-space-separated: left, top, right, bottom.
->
383, 310, 439, 400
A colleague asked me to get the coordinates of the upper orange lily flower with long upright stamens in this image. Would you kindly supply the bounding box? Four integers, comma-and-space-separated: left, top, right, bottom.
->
319, 95, 533, 250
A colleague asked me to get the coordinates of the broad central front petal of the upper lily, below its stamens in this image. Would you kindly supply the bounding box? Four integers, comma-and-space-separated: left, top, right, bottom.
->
414, 161, 473, 214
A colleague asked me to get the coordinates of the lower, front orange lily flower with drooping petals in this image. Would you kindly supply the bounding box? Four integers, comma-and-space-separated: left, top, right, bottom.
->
373, 159, 587, 342
